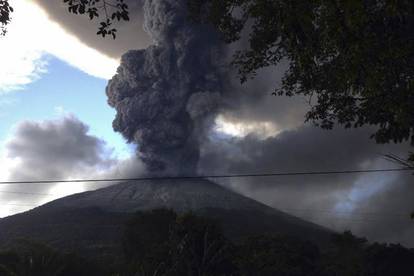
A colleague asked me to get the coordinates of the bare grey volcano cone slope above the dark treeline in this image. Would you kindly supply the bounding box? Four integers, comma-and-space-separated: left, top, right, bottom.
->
0, 179, 333, 255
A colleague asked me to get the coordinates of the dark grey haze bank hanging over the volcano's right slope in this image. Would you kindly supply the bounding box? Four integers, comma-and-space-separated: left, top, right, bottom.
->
200, 125, 414, 246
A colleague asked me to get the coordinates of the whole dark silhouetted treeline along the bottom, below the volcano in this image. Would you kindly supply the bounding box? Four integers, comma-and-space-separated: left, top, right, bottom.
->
0, 209, 414, 276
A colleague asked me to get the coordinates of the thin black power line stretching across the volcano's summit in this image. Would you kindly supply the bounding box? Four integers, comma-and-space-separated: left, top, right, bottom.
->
0, 167, 414, 185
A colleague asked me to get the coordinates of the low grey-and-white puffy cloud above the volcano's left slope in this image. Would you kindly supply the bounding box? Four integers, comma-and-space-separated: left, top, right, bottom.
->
0, 114, 145, 218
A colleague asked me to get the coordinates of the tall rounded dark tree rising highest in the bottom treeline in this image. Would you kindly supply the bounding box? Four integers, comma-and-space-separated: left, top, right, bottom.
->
123, 209, 234, 276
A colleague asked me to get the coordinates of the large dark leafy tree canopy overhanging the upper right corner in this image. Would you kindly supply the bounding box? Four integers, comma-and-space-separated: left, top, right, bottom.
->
189, 0, 414, 149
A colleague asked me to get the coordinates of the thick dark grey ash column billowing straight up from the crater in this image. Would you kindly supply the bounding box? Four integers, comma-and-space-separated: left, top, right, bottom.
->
106, 0, 223, 174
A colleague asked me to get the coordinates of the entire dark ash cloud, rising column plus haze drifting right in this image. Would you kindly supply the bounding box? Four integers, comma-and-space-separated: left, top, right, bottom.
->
29, 0, 414, 246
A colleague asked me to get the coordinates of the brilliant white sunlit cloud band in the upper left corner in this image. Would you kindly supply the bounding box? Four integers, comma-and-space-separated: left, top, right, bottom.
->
0, 0, 118, 92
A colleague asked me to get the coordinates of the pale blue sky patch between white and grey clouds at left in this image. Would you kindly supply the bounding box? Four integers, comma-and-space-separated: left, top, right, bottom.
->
0, 55, 129, 160
